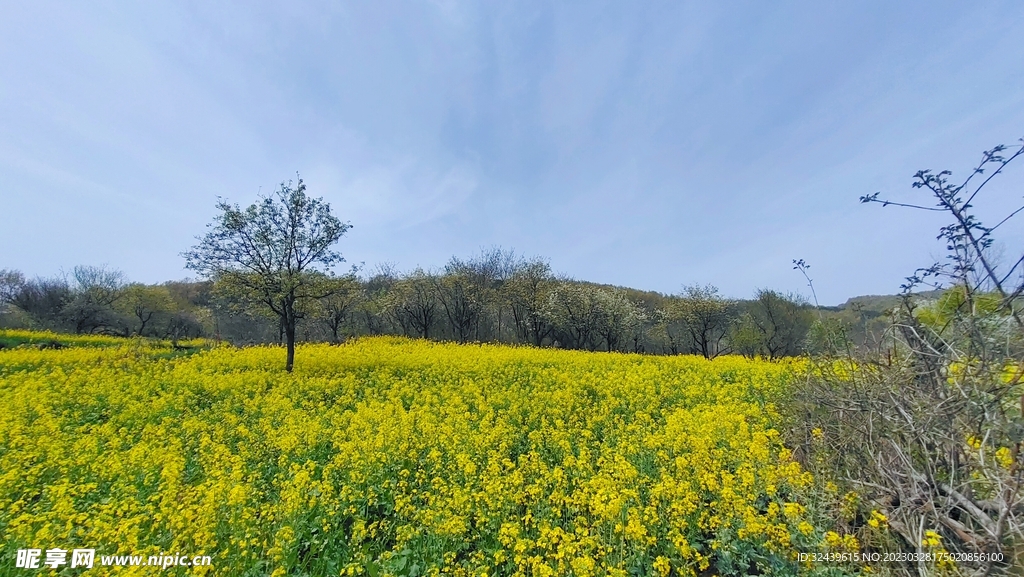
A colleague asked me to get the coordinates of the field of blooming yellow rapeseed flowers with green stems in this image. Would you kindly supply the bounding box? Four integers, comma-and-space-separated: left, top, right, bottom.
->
0, 337, 843, 577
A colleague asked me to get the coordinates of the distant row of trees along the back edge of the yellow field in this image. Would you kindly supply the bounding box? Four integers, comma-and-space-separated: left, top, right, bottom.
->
0, 248, 815, 359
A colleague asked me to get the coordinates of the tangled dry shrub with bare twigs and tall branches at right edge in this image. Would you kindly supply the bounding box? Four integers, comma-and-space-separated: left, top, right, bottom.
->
791, 140, 1024, 575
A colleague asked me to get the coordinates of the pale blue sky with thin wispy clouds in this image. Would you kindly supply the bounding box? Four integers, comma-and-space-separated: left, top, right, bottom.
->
0, 1, 1024, 303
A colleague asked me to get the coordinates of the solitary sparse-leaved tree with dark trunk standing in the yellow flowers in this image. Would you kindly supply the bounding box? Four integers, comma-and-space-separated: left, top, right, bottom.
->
183, 178, 351, 371
